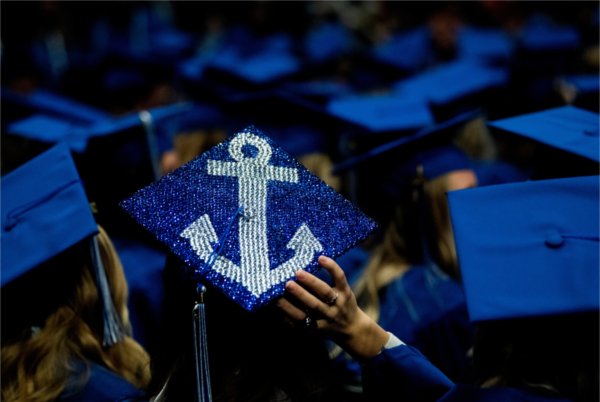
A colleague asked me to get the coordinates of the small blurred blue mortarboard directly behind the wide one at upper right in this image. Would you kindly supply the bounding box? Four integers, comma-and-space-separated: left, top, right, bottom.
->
458, 26, 514, 61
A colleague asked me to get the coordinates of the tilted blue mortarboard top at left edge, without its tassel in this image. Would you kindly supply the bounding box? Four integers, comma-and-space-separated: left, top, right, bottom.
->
0, 145, 98, 286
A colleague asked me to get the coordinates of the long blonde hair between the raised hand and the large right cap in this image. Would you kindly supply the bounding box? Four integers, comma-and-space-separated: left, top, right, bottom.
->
354, 174, 458, 321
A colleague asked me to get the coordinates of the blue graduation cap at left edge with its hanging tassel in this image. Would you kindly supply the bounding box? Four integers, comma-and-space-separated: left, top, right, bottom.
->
0, 145, 123, 345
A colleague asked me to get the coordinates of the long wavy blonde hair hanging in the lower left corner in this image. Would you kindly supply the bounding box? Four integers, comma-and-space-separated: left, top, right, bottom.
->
1, 228, 150, 402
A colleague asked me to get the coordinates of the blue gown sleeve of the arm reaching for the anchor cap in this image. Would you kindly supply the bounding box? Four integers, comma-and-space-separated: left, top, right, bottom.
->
363, 345, 454, 402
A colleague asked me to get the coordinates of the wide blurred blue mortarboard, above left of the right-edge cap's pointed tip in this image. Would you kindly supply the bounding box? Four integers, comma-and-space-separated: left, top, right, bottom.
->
393, 59, 508, 105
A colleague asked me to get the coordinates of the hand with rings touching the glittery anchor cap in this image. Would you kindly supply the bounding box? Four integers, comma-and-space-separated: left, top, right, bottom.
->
277, 256, 389, 359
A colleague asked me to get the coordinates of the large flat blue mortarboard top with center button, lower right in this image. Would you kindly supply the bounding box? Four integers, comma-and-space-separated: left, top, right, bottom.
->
448, 176, 600, 321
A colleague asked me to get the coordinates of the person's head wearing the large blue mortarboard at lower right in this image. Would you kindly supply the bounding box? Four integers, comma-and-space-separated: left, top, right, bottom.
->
448, 176, 600, 401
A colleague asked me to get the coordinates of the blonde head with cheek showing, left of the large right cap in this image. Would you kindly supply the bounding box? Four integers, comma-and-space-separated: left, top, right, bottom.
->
354, 159, 477, 319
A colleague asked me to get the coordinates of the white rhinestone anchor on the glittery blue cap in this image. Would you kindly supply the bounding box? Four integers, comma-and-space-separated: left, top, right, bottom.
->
180, 132, 323, 297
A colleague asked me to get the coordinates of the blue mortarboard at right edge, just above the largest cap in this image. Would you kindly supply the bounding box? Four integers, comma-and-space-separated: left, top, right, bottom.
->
488, 106, 600, 162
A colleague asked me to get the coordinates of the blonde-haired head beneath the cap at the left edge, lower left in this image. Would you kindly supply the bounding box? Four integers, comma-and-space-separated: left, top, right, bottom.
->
2, 228, 149, 401
